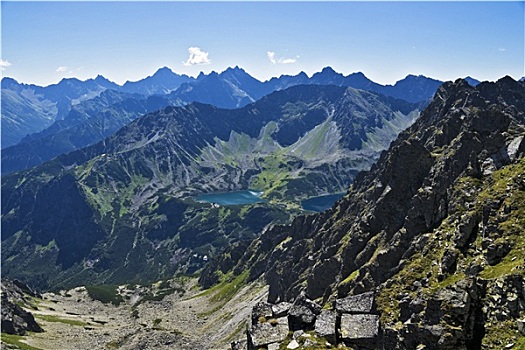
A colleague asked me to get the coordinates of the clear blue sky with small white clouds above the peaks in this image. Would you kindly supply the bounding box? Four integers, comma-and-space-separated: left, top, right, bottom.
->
1, 1, 525, 85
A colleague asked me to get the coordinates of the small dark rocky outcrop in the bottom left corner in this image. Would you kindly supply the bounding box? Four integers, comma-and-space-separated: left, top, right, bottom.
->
1, 279, 43, 335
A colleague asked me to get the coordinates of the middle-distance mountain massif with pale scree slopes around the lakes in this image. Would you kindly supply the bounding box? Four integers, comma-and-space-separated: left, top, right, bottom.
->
2, 85, 419, 288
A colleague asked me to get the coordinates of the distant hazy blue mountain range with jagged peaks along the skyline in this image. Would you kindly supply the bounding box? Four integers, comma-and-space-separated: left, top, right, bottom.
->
2, 67, 448, 153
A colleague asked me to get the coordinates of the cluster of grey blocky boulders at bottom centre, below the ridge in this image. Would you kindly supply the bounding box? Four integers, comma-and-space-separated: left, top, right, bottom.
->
235, 293, 380, 350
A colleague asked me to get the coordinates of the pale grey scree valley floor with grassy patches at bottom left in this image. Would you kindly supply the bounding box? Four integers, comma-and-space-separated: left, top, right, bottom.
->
2, 278, 268, 350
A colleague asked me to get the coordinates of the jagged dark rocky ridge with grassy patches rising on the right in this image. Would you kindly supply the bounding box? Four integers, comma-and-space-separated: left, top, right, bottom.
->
200, 77, 525, 349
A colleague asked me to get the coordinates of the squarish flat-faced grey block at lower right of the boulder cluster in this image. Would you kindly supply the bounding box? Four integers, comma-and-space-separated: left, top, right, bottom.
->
340, 314, 379, 341
